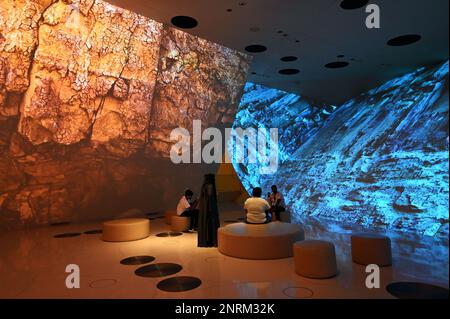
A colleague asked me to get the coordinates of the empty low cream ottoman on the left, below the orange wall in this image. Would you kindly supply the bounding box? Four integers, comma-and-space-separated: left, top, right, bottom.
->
102, 218, 150, 241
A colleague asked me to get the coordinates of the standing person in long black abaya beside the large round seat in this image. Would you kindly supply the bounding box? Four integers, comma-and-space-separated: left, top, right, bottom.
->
197, 174, 220, 247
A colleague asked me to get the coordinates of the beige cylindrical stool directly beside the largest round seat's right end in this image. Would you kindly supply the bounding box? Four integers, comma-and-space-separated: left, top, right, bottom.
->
294, 240, 337, 279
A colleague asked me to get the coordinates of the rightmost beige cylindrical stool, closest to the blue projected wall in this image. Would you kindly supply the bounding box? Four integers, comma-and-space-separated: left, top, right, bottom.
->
351, 234, 392, 267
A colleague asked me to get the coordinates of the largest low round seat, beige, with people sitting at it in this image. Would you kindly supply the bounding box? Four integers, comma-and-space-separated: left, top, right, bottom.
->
218, 222, 305, 259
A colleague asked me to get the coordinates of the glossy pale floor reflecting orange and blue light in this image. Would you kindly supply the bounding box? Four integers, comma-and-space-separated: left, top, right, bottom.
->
0, 205, 448, 299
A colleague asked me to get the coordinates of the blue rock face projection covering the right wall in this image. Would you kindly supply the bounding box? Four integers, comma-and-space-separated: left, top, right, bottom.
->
233, 62, 449, 237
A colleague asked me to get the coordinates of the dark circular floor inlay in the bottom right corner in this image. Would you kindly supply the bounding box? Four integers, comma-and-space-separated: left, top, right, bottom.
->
386, 282, 448, 299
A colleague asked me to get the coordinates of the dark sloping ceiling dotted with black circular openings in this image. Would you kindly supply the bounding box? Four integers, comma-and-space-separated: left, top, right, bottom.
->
108, 0, 449, 104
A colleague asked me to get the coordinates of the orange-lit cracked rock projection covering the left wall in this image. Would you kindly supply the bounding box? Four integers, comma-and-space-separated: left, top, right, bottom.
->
0, 0, 250, 228
